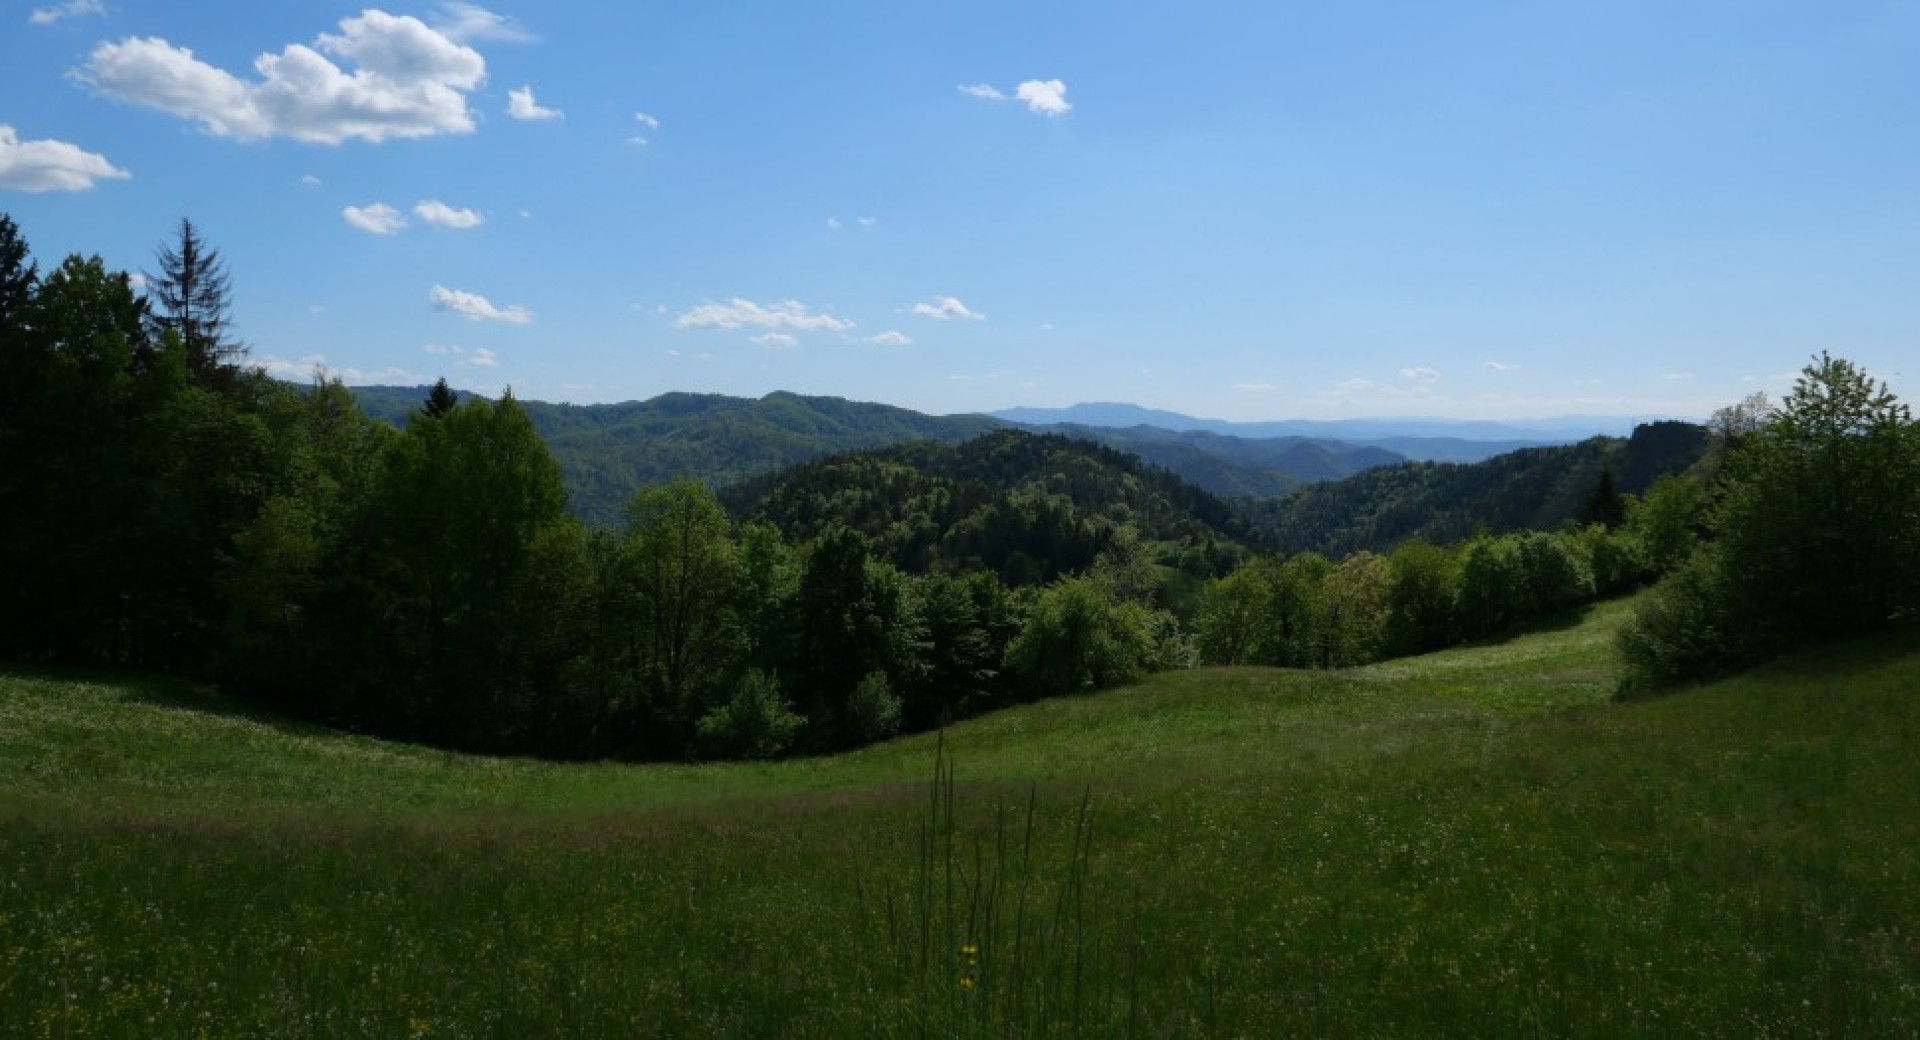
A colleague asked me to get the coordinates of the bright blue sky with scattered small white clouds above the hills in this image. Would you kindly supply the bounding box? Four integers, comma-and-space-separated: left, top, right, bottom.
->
0, 0, 1920, 420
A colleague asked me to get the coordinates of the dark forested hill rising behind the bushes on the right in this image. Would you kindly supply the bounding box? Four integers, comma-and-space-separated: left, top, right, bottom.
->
1246, 422, 1707, 556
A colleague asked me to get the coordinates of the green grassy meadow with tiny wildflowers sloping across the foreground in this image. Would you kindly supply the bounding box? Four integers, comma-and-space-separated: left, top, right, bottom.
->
0, 603, 1920, 1038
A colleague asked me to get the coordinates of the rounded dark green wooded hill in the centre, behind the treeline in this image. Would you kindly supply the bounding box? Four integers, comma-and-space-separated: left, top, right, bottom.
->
720, 430, 1246, 585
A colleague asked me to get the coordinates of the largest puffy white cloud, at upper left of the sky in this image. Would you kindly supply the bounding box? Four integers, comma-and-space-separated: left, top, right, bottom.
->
75, 10, 486, 144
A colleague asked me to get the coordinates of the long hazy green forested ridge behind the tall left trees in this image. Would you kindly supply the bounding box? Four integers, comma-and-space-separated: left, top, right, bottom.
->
353, 386, 1002, 526
